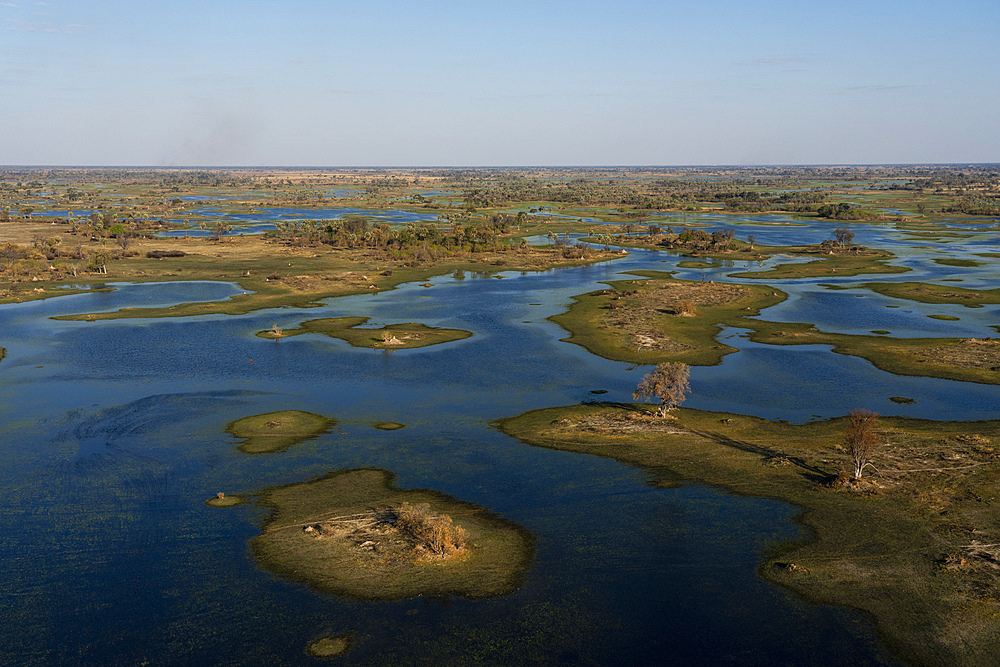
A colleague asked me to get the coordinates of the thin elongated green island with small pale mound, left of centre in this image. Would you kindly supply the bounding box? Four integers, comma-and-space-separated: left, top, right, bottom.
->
257, 317, 472, 350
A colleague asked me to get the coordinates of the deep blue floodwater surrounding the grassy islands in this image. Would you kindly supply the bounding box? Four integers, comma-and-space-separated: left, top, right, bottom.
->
0, 218, 1000, 665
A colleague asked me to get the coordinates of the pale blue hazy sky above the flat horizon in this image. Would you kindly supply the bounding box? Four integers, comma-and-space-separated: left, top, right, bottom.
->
0, 0, 1000, 167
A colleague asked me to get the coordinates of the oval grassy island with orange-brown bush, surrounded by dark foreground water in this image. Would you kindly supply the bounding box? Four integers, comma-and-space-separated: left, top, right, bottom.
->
250, 469, 534, 600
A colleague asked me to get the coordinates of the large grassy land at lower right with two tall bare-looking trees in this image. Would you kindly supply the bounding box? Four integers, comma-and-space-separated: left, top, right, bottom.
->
499, 404, 1000, 665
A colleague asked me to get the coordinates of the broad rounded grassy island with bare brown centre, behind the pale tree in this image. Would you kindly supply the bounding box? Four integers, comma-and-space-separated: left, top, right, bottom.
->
549, 271, 786, 366
